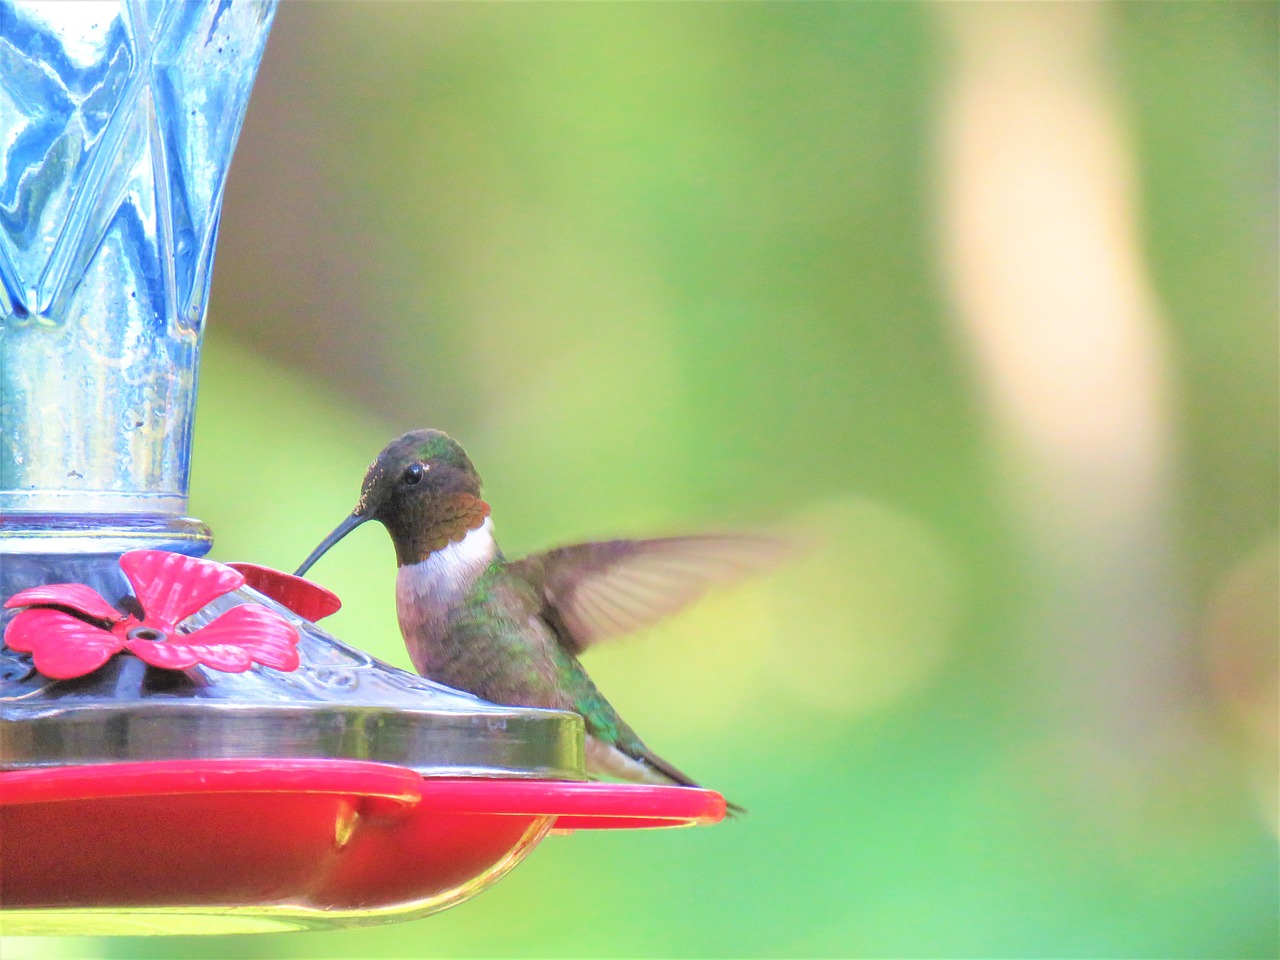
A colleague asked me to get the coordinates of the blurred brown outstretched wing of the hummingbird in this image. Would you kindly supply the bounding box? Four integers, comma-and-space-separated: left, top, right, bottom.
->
511, 534, 788, 654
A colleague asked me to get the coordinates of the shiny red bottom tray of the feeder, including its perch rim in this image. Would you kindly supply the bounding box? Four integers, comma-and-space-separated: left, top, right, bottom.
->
0, 759, 724, 934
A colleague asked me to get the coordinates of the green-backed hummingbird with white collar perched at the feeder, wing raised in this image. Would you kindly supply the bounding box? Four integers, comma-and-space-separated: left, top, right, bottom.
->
297, 430, 781, 812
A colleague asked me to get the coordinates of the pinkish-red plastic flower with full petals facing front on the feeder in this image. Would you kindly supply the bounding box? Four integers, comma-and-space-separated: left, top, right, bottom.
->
4, 550, 298, 680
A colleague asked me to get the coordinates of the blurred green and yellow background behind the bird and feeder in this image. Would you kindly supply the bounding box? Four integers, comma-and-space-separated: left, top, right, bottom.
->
15, 3, 1280, 959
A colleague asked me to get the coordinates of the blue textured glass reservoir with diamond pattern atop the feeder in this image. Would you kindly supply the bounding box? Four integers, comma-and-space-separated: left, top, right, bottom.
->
0, 0, 274, 550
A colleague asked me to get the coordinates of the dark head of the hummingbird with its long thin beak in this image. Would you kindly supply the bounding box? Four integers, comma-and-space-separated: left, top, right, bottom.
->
297, 430, 489, 576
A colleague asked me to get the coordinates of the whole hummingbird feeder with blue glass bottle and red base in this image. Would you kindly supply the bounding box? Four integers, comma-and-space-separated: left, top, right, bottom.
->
0, 0, 724, 934
